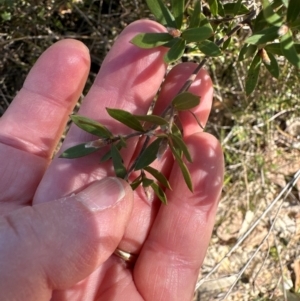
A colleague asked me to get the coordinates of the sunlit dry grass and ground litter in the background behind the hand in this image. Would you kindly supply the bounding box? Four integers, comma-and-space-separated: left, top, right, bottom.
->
0, 0, 300, 300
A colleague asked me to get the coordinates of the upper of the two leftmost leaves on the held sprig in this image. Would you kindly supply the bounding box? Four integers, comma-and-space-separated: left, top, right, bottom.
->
70, 115, 113, 138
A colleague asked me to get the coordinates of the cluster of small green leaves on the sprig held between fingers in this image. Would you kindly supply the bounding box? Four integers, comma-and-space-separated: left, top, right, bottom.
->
60, 92, 200, 204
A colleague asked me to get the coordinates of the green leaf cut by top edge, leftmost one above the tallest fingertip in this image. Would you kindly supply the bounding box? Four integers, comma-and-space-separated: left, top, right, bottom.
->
146, 0, 176, 28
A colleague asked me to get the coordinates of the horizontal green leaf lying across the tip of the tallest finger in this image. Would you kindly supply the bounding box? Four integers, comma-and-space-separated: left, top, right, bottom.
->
131, 32, 173, 49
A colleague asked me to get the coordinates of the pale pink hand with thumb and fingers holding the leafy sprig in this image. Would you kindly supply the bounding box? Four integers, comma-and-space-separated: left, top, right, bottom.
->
0, 20, 223, 301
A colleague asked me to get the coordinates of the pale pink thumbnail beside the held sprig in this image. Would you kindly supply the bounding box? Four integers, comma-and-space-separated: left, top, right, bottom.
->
76, 177, 125, 211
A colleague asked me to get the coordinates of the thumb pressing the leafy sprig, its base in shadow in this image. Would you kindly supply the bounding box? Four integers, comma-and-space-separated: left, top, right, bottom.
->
0, 178, 133, 300
